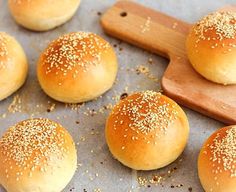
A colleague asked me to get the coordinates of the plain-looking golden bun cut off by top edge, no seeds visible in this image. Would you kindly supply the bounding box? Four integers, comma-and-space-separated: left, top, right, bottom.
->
8, 0, 80, 31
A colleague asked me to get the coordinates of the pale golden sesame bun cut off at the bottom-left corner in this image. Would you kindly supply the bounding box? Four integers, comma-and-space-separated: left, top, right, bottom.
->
0, 119, 77, 192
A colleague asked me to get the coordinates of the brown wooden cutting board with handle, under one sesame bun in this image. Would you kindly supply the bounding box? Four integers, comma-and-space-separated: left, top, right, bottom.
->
101, 0, 236, 124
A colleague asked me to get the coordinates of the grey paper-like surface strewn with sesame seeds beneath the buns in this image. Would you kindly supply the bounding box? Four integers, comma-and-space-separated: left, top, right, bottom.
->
0, 0, 236, 192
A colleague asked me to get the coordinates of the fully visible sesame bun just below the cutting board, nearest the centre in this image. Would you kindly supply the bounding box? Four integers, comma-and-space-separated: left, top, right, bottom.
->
105, 91, 189, 170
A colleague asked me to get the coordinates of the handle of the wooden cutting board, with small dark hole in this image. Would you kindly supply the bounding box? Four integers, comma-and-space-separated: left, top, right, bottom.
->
101, 0, 190, 58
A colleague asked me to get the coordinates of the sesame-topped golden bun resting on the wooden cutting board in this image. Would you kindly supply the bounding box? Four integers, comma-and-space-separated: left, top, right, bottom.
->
186, 12, 236, 85
